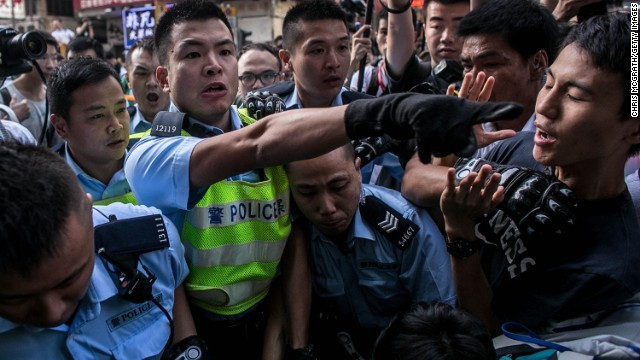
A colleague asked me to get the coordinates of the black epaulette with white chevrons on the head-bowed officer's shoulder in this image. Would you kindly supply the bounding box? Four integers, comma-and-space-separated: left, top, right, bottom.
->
360, 195, 420, 250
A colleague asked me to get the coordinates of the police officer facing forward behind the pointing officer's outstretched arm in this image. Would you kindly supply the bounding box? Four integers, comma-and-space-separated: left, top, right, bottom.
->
264, 0, 413, 190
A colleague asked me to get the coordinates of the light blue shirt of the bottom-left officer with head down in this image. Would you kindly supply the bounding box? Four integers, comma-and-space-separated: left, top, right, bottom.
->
0, 203, 189, 360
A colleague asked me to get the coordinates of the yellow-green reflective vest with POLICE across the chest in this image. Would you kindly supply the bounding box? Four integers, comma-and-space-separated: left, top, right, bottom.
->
182, 109, 291, 315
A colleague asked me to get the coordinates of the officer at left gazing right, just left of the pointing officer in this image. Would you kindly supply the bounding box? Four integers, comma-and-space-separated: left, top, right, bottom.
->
47, 58, 135, 205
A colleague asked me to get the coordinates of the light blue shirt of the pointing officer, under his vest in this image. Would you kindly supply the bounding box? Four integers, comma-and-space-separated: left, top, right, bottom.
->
124, 104, 260, 229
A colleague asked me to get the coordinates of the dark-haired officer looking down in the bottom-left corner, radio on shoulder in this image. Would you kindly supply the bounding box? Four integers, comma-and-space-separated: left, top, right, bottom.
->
0, 144, 202, 359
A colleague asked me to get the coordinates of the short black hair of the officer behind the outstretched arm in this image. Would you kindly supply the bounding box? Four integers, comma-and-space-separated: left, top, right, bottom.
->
282, 0, 349, 51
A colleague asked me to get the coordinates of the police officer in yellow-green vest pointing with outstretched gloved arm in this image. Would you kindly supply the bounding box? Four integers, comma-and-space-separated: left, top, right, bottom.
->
125, 0, 519, 359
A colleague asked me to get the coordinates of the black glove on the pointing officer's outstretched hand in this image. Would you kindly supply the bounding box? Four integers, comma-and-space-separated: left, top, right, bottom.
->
344, 93, 522, 163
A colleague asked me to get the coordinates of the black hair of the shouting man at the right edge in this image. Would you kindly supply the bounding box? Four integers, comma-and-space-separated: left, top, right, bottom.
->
562, 13, 640, 155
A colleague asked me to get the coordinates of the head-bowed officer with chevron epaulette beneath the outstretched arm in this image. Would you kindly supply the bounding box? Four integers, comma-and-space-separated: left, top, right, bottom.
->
286, 145, 456, 359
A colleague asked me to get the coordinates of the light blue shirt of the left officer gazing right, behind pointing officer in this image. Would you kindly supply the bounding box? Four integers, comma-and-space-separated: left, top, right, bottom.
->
64, 143, 131, 201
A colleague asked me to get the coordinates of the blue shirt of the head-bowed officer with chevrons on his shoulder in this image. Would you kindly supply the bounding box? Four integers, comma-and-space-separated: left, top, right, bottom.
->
309, 185, 456, 329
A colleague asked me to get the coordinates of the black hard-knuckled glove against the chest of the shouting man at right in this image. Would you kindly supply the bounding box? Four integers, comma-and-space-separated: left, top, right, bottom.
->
455, 159, 578, 237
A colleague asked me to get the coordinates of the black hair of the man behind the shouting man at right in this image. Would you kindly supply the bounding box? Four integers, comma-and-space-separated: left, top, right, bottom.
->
458, 0, 560, 63
